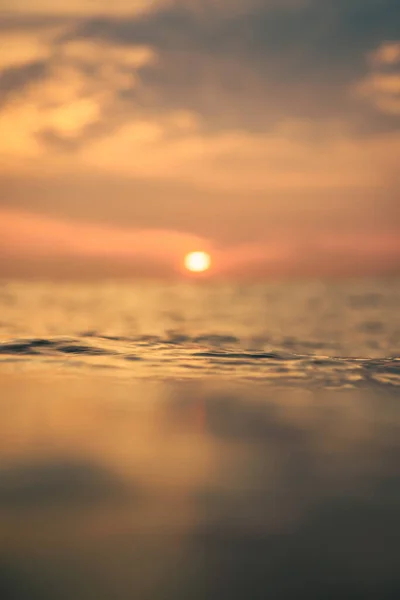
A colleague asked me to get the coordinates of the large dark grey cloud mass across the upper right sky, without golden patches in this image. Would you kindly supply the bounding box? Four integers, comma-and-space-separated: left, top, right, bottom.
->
64, 0, 400, 129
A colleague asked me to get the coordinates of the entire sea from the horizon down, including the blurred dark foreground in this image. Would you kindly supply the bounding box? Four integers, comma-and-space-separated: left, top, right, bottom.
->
0, 277, 400, 600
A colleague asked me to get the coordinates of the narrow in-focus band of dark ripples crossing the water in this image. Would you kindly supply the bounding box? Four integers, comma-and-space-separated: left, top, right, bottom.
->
0, 332, 400, 387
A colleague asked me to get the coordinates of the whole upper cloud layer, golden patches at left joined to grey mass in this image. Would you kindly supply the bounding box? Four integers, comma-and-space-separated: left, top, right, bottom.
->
0, 0, 398, 163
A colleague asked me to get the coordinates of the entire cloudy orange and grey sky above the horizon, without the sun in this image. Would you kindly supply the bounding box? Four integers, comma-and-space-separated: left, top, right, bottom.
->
0, 0, 400, 280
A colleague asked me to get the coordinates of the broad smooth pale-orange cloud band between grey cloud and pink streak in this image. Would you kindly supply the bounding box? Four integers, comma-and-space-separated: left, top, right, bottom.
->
0, 115, 400, 258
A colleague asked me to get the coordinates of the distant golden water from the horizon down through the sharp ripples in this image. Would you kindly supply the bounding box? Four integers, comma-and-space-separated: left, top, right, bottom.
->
0, 279, 400, 387
